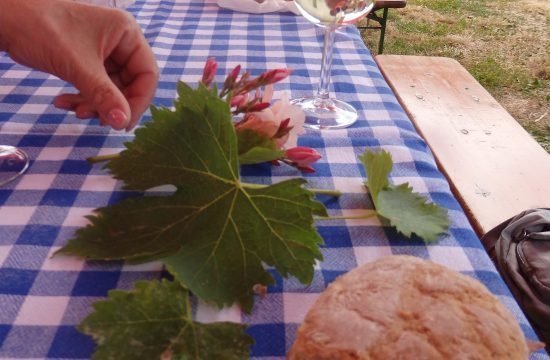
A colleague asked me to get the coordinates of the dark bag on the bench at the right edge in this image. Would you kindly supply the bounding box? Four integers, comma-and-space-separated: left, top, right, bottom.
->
481, 209, 550, 344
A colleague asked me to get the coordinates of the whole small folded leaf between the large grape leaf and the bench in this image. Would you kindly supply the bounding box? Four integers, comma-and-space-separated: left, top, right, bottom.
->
359, 150, 450, 242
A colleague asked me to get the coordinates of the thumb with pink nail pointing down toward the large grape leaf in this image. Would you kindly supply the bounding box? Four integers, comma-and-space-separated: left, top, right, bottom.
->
75, 69, 132, 130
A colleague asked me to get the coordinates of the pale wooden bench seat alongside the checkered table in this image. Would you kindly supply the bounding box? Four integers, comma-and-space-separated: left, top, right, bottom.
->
376, 55, 550, 236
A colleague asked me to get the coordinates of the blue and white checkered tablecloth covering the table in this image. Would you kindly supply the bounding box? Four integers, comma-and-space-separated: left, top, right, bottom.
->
0, 0, 547, 359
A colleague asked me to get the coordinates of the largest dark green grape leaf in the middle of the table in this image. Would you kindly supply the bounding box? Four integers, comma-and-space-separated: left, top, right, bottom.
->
60, 84, 326, 310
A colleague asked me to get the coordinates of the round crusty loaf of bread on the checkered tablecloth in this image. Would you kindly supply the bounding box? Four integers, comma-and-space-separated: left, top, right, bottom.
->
288, 256, 529, 360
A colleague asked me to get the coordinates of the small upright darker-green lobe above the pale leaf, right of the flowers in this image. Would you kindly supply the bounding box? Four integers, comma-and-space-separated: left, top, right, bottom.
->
359, 150, 393, 206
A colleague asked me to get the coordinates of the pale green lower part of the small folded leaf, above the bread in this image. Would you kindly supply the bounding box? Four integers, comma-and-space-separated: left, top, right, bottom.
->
376, 183, 449, 242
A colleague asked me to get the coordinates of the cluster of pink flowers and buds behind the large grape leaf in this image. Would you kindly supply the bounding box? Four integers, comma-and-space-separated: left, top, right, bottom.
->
201, 58, 321, 172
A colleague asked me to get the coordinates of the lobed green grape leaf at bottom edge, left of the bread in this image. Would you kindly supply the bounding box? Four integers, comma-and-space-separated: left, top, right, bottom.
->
78, 280, 253, 360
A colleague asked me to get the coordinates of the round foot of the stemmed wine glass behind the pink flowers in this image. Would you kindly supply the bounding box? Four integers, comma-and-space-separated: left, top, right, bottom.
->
291, 97, 357, 130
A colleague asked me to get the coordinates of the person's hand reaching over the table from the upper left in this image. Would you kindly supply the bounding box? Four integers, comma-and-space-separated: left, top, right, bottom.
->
0, 0, 158, 131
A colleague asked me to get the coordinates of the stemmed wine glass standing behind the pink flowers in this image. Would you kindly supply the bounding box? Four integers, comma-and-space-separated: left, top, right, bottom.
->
292, 0, 374, 129
